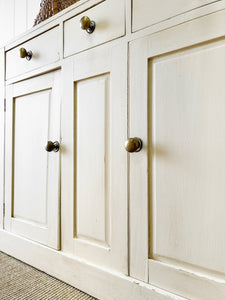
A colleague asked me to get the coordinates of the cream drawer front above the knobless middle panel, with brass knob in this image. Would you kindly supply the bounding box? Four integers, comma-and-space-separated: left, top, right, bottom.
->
64, 0, 125, 57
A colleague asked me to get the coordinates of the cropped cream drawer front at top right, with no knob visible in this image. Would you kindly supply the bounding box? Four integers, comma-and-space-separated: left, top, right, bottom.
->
132, 0, 218, 32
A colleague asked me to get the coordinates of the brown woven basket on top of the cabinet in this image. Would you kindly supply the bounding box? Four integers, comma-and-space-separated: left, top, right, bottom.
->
34, 0, 79, 26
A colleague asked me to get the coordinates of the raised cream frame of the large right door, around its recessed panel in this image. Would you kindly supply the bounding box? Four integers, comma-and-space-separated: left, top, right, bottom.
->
129, 10, 225, 299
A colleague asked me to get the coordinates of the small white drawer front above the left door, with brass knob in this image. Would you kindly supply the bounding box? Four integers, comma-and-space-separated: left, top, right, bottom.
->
6, 26, 59, 79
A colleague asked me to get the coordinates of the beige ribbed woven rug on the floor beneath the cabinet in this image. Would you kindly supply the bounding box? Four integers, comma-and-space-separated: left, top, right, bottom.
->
0, 252, 95, 300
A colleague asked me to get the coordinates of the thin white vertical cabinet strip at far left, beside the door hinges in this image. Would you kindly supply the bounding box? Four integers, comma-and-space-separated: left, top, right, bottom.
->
0, 48, 5, 229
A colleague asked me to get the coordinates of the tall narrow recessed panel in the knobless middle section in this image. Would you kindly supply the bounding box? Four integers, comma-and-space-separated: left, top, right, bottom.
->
75, 75, 110, 246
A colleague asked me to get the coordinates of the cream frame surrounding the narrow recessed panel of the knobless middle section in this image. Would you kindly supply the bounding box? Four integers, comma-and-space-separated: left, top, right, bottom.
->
61, 41, 128, 274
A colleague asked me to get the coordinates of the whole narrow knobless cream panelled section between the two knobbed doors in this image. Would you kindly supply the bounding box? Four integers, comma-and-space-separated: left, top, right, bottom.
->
62, 43, 127, 273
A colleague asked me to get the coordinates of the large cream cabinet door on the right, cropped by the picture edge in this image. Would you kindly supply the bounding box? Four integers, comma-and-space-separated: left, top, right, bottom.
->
129, 11, 225, 300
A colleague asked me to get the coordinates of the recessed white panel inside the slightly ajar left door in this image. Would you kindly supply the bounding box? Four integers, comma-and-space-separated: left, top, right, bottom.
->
13, 90, 51, 226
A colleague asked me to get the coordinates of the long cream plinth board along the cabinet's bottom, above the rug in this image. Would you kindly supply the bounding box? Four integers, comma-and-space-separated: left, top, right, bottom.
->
0, 230, 185, 300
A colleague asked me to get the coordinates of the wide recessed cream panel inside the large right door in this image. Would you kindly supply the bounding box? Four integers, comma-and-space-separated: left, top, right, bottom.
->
149, 41, 225, 272
